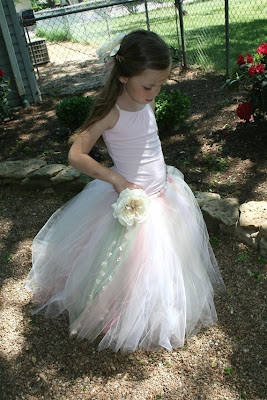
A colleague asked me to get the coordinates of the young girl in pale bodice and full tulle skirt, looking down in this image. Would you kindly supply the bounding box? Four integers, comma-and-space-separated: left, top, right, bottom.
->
27, 30, 223, 351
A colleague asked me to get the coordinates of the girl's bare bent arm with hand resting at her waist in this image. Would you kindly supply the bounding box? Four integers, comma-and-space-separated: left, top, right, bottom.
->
68, 108, 139, 193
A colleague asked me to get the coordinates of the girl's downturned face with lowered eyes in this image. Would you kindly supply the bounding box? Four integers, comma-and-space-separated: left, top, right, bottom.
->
120, 68, 170, 107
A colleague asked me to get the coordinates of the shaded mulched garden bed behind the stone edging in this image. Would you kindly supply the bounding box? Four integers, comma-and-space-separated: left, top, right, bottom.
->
0, 68, 267, 203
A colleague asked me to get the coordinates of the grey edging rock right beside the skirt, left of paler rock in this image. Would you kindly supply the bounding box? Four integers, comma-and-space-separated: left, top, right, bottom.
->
202, 198, 239, 232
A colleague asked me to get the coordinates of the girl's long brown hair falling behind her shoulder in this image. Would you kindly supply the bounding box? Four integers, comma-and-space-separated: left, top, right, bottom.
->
80, 30, 171, 132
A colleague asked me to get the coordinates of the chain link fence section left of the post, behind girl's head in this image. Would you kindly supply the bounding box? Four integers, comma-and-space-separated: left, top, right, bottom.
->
24, 0, 179, 94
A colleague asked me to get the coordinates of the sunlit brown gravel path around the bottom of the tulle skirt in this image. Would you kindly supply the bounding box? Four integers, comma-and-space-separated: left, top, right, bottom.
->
0, 188, 267, 400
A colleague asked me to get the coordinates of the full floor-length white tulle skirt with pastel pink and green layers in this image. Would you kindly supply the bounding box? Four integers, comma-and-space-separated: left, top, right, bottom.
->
26, 167, 226, 351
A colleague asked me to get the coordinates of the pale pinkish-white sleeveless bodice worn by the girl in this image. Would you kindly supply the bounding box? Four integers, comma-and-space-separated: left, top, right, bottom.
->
103, 105, 166, 195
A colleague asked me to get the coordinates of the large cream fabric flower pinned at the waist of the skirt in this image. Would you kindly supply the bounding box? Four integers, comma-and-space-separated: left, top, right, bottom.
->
111, 188, 151, 227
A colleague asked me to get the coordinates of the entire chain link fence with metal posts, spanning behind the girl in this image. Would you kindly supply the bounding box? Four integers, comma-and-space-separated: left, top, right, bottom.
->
24, 0, 267, 95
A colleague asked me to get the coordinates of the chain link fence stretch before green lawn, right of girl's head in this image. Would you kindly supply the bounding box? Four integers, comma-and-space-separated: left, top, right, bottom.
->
177, 0, 267, 73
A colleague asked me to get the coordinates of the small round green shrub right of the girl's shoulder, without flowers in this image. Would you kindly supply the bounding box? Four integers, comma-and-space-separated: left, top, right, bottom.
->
155, 90, 190, 129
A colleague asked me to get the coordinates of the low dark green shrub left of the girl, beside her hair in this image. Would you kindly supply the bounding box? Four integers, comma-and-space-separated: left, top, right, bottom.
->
56, 96, 94, 129
